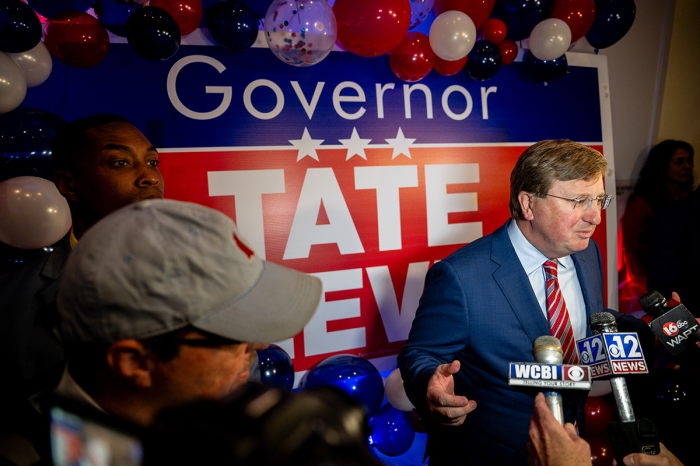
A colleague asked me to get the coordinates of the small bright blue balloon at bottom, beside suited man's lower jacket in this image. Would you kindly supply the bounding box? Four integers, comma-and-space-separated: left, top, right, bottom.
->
371, 402, 412, 456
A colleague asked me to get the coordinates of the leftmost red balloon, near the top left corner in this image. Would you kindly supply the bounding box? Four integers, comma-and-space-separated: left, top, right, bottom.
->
44, 10, 109, 68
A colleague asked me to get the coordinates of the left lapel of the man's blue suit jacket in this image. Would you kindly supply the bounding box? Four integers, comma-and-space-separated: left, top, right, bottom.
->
491, 223, 550, 341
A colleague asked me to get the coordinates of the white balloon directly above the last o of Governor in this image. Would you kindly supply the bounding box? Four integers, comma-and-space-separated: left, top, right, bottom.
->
429, 10, 476, 61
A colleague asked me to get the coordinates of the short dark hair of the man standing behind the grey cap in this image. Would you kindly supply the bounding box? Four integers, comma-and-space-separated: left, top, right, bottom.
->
51, 113, 133, 171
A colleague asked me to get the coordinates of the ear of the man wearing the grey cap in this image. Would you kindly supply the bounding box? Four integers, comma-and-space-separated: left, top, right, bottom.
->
107, 340, 153, 387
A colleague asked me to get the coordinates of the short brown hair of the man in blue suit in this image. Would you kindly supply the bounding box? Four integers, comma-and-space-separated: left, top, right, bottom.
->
510, 139, 608, 219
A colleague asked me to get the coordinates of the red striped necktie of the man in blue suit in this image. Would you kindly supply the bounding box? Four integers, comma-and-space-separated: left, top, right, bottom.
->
544, 261, 578, 364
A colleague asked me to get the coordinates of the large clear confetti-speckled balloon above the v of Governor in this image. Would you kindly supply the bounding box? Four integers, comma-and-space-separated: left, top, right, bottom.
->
265, 0, 338, 66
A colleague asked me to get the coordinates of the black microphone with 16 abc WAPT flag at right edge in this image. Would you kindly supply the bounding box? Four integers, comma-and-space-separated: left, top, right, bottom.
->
639, 291, 700, 356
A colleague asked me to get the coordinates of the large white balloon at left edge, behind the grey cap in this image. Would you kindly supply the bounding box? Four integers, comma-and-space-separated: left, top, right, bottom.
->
0, 176, 71, 249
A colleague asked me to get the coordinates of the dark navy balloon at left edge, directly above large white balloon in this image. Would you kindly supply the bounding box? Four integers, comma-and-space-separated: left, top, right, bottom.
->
0, 108, 66, 181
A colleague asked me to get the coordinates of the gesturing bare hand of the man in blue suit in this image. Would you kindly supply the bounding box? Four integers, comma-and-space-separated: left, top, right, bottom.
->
425, 361, 476, 426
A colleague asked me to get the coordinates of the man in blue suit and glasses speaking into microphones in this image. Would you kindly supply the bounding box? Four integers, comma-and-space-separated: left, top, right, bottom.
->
399, 140, 648, 465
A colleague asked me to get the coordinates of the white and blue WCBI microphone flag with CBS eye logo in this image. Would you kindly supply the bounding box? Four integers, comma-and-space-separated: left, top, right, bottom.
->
508, 362, 591, 390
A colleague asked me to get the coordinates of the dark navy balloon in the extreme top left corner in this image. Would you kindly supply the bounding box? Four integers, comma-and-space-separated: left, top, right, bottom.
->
0, 0, 41, 53
